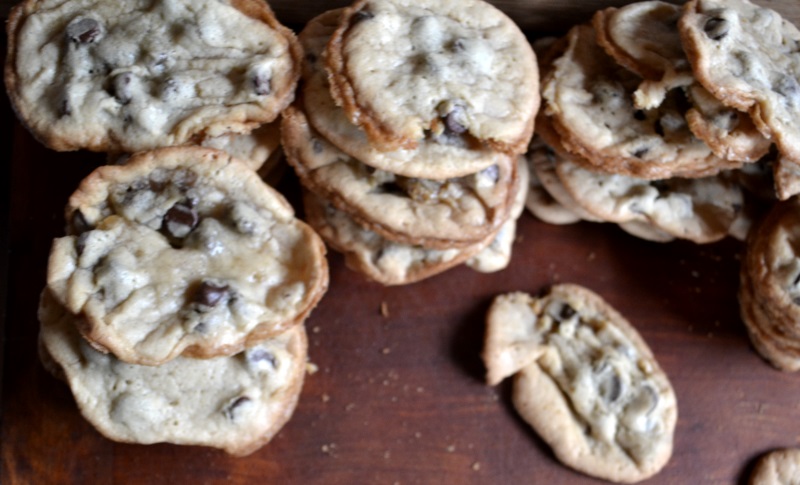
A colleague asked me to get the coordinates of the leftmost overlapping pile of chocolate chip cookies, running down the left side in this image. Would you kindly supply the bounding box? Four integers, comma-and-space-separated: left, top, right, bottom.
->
5, 0, 328, 455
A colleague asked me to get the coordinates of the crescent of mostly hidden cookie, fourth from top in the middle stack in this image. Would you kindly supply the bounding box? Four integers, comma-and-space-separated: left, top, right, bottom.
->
303, 190, 488, 286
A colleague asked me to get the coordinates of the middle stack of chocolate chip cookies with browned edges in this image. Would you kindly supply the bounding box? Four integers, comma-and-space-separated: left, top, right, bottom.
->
282, 0, 539, 285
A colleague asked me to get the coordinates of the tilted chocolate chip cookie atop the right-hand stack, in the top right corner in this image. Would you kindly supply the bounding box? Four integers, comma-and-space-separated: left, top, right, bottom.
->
679, 0, 800, 164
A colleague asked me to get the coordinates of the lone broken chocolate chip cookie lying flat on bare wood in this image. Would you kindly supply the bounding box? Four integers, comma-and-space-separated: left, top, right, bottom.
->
482, 284, 677, 482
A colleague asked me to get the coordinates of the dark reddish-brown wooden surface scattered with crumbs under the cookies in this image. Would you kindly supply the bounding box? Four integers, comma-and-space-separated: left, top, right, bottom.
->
0, 0, 800, 485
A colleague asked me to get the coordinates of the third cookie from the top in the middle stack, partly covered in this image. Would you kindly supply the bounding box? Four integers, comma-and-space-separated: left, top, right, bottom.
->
281, 106, 517, 249
